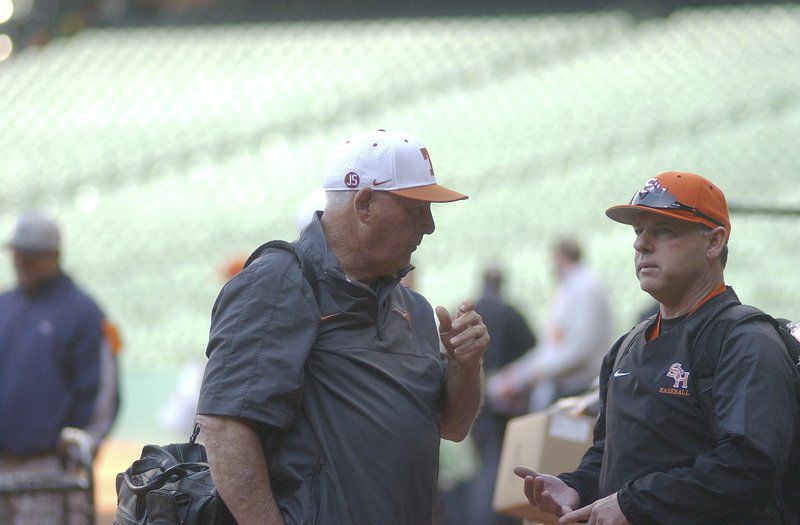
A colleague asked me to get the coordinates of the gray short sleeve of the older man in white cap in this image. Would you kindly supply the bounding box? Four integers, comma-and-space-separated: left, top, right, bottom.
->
198, 250, 319, 430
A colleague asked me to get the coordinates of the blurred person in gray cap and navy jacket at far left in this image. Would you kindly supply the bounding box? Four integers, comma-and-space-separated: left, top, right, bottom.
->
0, 213, 116, 524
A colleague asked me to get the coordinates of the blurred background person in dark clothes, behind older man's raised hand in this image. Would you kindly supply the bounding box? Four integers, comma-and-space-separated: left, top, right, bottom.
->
444, 262, 536, 525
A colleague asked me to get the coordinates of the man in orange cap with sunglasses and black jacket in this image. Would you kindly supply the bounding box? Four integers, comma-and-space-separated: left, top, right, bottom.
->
516, 172, 800, 524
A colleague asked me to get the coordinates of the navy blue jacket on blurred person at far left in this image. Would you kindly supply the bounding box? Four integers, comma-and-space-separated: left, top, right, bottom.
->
0, 274, 103, 455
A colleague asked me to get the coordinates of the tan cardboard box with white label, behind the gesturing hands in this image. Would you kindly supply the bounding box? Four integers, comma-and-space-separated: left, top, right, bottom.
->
493, 411, 594, 523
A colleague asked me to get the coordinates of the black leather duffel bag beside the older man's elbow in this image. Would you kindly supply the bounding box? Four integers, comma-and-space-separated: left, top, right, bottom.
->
114, 427, 236, 525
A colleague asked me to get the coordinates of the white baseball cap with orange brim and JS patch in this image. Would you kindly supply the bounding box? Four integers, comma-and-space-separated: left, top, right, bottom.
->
324, 129, 467, 202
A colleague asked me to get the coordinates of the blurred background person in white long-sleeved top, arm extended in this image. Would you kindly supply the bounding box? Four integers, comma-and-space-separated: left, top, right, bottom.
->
487, 237, 613, 412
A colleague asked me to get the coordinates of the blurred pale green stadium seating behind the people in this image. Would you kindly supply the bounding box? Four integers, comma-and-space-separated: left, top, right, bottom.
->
0, 0, 800, 516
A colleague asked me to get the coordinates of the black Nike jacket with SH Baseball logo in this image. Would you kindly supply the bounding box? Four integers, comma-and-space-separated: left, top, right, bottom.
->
559, 288, 800, 525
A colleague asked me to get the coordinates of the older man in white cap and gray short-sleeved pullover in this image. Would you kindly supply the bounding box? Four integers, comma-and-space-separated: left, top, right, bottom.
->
198, 130, 489, 525
